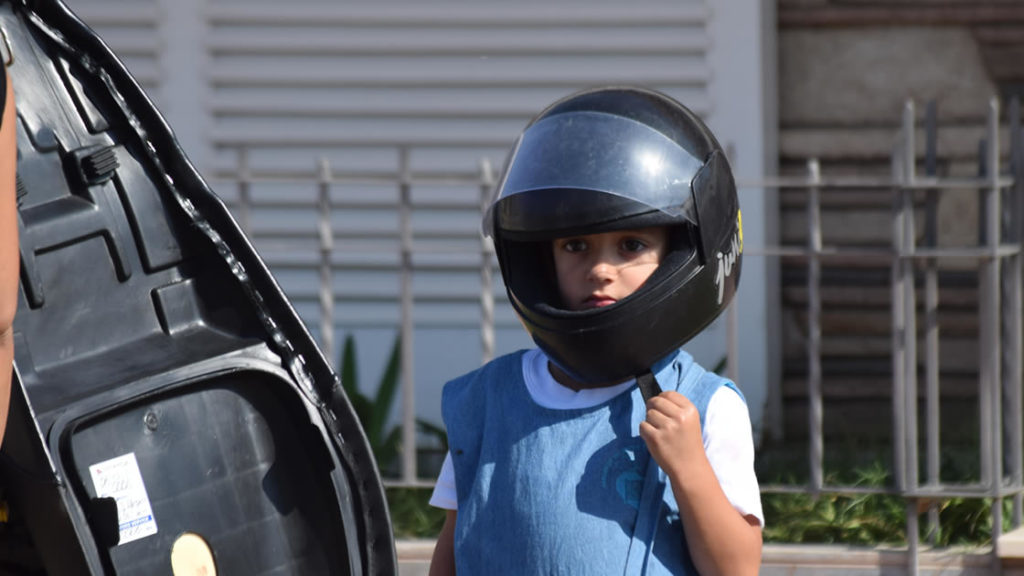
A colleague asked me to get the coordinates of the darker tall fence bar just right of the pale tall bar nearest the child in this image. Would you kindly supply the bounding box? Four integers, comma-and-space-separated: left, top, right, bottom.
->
925, 100, 942, 544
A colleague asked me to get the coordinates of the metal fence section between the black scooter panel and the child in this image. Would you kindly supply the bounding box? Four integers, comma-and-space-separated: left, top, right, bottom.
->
218, 146, 501, 486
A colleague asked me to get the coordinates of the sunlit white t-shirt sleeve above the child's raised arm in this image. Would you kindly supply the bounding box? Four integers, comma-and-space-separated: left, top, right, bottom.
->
702, 386, 765, 527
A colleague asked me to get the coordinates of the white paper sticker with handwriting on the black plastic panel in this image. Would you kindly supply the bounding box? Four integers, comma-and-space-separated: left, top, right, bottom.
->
89, 452, 157, 545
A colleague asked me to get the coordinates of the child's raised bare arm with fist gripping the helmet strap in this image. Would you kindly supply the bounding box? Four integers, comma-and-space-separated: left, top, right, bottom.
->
640, 392, 761, 576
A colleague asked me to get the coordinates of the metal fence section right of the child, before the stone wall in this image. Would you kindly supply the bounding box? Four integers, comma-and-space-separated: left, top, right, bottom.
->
749, 99, 1024, 575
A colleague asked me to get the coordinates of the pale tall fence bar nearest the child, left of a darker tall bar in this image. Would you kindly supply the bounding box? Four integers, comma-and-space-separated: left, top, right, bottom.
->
899, 100, 920, 576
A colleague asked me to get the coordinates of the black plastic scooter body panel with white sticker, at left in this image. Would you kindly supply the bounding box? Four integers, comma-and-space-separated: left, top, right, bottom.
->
0, 0, 397, 576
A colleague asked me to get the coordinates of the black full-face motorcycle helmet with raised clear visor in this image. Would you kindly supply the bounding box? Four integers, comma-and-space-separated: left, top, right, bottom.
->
483, 87, 742, 384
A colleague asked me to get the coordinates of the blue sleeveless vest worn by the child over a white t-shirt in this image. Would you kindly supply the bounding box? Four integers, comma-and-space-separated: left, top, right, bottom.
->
441, 351, 739, 576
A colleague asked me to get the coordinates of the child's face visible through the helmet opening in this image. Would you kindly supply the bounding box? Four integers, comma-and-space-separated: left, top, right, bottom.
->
553, 227, 669, 310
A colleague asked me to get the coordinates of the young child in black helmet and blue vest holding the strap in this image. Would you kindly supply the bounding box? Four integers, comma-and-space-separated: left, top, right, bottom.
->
430, 88, 763, 576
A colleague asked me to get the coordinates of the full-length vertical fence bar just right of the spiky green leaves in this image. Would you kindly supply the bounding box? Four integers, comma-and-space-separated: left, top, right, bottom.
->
398, 147, 418, 484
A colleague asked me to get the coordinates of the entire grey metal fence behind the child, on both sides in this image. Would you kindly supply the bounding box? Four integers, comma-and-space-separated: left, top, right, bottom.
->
220, 100, 1024, 575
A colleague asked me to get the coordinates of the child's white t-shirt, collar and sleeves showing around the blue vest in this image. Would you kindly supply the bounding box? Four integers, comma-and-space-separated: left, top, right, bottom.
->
430, 348, 765, 526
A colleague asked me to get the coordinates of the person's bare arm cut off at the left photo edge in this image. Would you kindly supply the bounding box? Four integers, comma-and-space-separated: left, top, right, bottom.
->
0, 69, 18, 443
